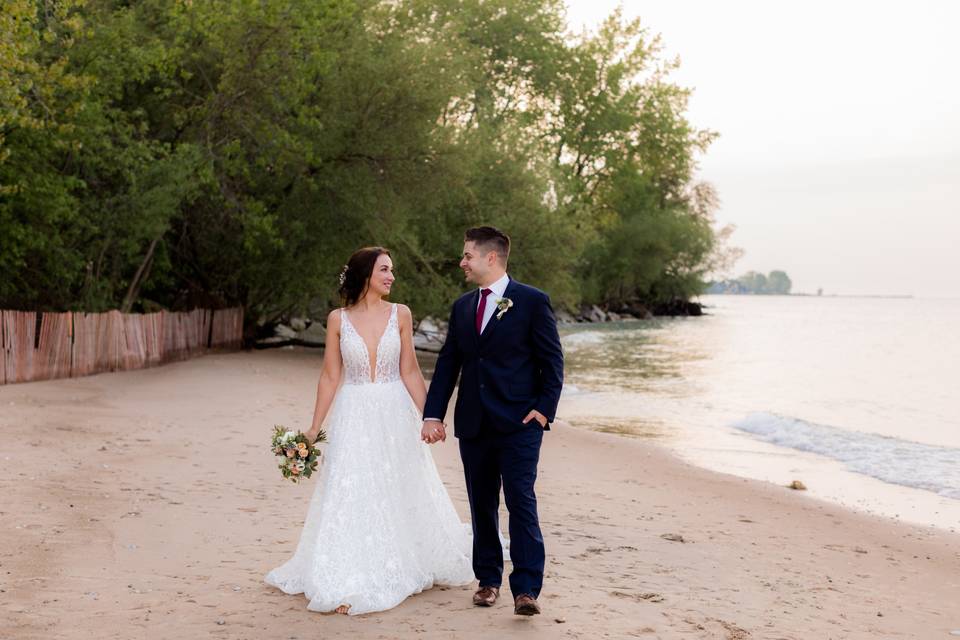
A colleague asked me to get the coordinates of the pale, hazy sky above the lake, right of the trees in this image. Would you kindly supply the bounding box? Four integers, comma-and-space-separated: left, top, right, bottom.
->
567, 0, 960, 297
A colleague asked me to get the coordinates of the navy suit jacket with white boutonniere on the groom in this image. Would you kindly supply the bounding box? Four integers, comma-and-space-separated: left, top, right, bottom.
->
423, 278, 563, 438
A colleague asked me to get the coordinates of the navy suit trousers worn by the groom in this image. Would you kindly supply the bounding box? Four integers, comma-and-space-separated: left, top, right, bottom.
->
459, 420, 545, 597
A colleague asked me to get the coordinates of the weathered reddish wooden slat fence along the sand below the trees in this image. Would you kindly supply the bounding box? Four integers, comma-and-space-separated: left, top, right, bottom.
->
0, 307, 243, 384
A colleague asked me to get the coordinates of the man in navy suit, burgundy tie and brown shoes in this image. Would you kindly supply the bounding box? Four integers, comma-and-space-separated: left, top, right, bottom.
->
421, 227, 563, 616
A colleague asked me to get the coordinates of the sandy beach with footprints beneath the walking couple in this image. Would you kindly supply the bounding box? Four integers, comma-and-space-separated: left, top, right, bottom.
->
0, 348, 960, 640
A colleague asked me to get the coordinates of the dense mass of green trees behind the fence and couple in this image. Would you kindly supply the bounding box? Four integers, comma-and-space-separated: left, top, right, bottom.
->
0, 0, 729, 320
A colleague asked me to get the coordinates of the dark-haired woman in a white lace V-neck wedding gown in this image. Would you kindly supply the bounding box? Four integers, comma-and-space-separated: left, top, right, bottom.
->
265, 247, 473, 614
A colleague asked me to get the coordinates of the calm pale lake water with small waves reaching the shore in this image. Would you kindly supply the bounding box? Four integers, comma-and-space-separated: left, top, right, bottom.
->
559, 296, 960, 529
